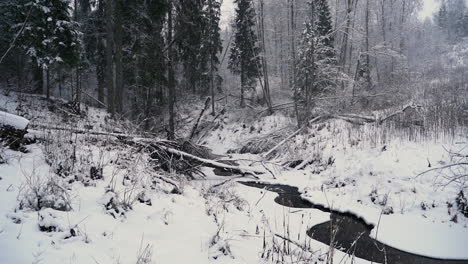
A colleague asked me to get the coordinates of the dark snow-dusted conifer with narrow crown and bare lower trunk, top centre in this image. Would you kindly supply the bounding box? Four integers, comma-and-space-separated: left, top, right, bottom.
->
228, 0, 261, 107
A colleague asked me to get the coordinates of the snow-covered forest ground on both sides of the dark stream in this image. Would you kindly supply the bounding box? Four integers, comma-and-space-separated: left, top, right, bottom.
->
0, 89, 468, 264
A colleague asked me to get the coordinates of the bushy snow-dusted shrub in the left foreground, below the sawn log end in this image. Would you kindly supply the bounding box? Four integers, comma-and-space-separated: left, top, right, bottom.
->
18, 169, 72, 211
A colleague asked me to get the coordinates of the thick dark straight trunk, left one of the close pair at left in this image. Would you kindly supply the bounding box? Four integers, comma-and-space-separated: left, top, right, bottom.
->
106, 0, 115, 115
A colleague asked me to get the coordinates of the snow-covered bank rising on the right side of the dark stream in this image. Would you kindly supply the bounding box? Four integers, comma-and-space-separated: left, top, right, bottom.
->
207, 111, 468, 259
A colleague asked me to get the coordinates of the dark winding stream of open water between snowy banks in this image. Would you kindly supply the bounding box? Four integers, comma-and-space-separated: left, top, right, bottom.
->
240, 182, 468, 264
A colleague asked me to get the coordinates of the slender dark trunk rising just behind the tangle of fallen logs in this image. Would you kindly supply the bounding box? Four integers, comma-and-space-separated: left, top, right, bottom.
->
167, 0, 176, 139
